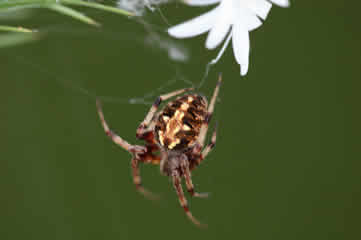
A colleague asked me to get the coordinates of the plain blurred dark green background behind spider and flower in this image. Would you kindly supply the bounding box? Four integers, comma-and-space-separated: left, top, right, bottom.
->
0, 1, 361, 240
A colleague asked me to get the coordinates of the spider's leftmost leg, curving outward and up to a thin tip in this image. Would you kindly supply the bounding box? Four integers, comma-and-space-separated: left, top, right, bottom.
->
96, 99, 146, 153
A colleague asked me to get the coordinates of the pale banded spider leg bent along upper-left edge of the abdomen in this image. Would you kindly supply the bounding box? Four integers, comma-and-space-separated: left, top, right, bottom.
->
137, 88, 193, 139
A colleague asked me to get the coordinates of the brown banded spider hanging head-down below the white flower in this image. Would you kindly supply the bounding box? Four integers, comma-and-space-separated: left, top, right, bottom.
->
97, 76, 222, 226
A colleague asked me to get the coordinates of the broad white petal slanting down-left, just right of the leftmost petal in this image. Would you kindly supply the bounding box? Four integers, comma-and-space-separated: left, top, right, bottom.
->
206, 3, 233, 49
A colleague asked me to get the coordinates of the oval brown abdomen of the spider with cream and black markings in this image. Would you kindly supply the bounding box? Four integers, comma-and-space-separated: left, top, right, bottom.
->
154, 94, 207, 150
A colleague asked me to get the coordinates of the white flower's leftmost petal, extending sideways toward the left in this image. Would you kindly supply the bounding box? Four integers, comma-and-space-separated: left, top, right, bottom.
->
168, 7, 219, 38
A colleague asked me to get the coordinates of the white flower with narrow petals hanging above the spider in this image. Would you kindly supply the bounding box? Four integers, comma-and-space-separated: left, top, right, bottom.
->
168, 0, 289, 76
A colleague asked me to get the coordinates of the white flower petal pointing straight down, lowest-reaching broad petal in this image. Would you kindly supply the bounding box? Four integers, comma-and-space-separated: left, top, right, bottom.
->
232, 22, 250, 76
